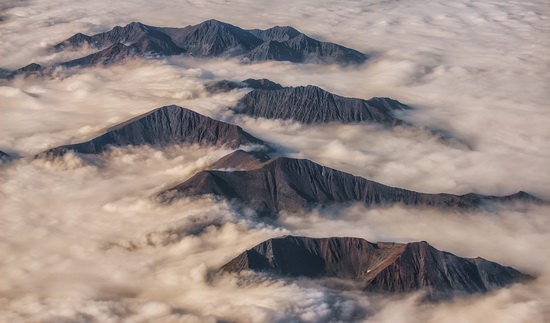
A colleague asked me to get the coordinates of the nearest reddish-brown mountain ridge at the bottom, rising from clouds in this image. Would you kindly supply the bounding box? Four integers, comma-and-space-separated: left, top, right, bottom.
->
221, 236, 529, 297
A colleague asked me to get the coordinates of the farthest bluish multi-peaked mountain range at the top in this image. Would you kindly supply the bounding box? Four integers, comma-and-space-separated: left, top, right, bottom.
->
8, 20, 367, 76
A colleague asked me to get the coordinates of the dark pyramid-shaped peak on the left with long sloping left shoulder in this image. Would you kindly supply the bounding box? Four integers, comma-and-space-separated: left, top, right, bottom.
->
43, 105, 266, 155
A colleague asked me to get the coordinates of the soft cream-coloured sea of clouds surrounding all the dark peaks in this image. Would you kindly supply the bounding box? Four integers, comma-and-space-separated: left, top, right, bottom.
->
0, 0, 550, 322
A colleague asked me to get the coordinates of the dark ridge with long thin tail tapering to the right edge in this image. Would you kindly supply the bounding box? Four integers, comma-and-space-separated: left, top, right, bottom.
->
167, 151, 538, 217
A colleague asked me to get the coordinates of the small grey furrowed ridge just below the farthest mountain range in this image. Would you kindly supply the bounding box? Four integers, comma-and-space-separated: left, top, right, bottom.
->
233, 85, 411, 125
